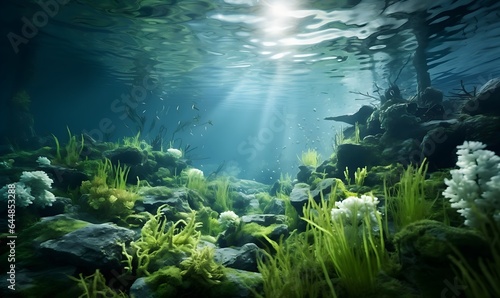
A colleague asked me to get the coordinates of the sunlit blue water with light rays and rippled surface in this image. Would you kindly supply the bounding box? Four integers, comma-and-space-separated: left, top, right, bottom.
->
0, 0, 500, 182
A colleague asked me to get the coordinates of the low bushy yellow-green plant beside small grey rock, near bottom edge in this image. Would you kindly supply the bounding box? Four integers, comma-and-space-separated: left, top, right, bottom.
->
180, 246, 224, 286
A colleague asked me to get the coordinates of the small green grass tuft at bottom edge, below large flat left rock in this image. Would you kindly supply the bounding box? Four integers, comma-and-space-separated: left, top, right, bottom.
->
69, 269, 128, 298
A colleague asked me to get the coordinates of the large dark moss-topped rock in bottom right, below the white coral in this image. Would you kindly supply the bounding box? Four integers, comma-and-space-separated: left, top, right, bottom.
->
394, 220, 488, 297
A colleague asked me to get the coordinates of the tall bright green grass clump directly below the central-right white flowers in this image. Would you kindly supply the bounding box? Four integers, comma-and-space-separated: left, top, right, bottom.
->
303, 190, 388, 297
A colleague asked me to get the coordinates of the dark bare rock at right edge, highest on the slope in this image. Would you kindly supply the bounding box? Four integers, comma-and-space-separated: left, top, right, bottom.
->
462, 78, 500, 116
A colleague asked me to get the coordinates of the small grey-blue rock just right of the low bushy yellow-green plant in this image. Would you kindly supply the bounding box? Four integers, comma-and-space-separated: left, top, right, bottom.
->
215, 243, 259, 272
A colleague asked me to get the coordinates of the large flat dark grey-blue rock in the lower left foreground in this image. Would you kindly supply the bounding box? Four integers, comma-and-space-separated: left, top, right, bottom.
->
40, 223, 135, 270
